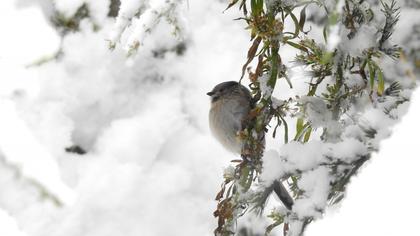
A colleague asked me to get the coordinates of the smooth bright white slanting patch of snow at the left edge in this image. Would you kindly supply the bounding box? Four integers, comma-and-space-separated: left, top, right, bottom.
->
0, 100, 75, 204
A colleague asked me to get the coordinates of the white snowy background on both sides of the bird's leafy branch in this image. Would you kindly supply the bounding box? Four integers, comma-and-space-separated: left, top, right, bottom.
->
0, 0, 420, 236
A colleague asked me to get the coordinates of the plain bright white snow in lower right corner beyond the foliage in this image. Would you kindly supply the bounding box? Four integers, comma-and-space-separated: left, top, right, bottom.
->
307, 90, 420, 236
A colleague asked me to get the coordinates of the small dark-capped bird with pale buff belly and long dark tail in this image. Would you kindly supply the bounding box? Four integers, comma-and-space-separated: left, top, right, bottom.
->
207, 81, 293, 210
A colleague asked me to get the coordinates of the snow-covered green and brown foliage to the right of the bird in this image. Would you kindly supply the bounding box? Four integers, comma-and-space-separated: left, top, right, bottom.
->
215, 0, 415, 236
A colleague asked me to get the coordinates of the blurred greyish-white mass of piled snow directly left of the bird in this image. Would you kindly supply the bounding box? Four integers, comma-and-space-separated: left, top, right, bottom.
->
0, 2, 248, 236
